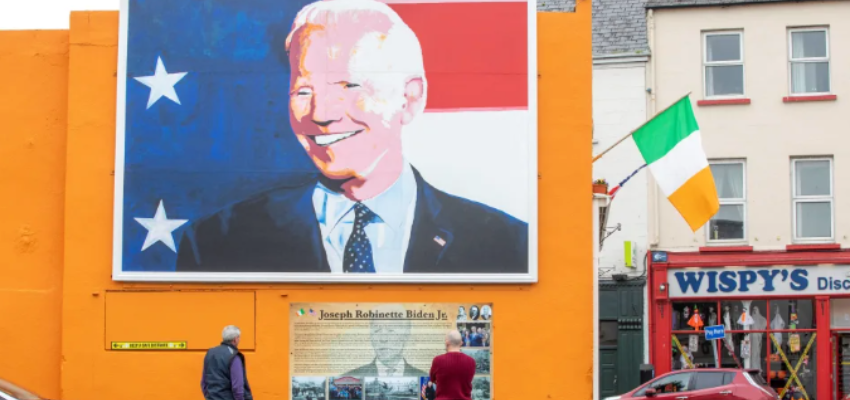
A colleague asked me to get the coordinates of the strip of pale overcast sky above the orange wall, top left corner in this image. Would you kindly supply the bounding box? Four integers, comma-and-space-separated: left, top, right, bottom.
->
0, 0, 119, 30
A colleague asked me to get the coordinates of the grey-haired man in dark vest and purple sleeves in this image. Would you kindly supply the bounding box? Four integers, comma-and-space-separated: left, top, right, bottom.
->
201, 325, 254, 400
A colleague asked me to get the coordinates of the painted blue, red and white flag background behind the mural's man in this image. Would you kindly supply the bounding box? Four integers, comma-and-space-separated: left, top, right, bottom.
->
116, 0, 536, 272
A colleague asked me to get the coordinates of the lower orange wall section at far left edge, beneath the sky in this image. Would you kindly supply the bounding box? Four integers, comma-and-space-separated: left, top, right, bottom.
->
0, 31, 68, 397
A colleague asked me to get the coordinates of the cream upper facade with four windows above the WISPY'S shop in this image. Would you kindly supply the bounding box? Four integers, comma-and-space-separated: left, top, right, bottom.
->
648, 0, 850, 251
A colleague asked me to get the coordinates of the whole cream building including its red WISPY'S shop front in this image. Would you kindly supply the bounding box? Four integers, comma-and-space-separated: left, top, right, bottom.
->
647, 0, 850, 400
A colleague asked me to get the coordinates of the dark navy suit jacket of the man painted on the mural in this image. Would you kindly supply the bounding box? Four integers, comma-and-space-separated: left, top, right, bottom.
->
177, 169, 528, 273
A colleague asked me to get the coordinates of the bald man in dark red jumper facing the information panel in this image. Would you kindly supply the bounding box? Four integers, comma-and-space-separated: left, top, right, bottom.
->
431, 330, 475, 400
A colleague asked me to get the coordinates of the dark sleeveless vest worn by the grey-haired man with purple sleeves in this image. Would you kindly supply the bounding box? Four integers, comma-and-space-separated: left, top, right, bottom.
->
204, 343, 254, 400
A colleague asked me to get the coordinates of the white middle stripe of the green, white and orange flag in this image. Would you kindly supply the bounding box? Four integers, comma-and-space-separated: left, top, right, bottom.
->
649, 131, 708, 197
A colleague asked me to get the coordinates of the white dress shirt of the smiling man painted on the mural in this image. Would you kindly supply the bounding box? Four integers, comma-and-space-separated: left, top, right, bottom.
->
313, 162, 416, 274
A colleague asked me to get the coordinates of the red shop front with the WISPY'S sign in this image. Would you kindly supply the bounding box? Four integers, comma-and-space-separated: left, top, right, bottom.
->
648, 246, 850, 400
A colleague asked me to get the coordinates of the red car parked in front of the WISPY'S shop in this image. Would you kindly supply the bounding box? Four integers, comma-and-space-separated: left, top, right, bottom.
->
605, 368, 779, 400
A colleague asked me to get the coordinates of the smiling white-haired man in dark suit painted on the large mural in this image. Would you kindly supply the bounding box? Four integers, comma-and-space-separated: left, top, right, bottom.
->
177, 0, 528, 274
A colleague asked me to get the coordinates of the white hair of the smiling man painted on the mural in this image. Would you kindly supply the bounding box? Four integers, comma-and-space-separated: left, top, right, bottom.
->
286, 0, 428, 123
